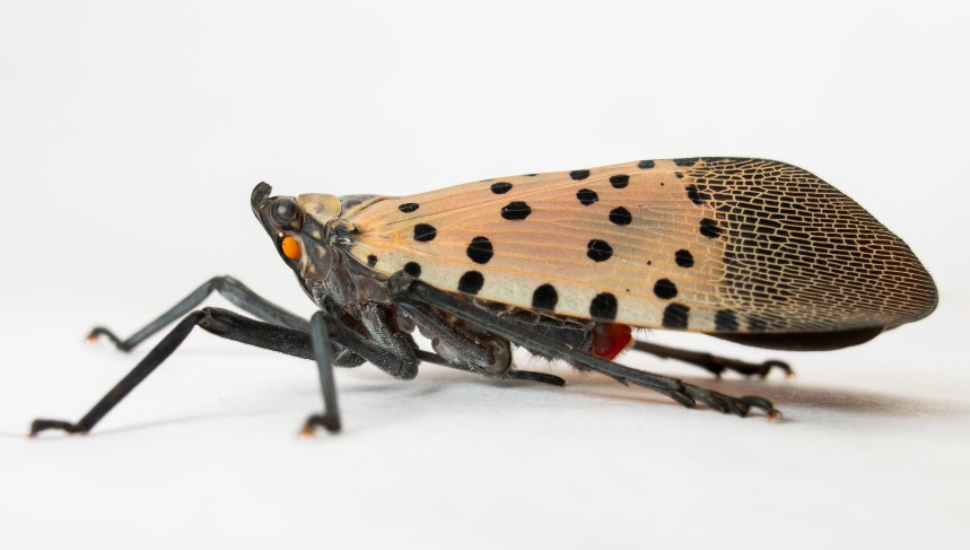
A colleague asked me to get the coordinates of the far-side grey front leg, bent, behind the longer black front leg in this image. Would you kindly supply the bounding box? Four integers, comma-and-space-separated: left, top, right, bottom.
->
88, 275, 310, 351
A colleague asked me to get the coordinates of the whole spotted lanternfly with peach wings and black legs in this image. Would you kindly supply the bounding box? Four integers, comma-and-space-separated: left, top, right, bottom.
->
32, 157, 937, 434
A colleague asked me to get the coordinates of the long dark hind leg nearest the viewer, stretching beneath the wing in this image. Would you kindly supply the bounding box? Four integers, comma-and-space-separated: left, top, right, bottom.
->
388, 272, 778, 417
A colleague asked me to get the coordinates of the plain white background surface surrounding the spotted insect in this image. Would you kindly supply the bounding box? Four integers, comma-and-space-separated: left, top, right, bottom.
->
0, 1, 970, 548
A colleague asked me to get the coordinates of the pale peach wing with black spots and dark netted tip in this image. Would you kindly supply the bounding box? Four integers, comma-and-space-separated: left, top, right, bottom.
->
349, 158, 936, 332
